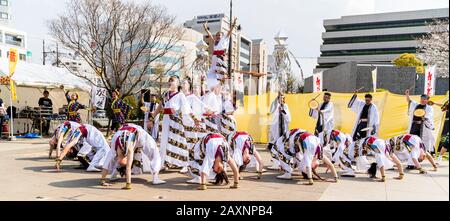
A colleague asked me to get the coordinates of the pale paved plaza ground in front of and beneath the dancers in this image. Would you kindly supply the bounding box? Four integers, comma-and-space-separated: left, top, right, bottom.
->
0, 139, 449, 201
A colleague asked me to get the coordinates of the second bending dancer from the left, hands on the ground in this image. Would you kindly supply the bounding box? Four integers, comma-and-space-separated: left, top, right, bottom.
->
101, 124, 165, 190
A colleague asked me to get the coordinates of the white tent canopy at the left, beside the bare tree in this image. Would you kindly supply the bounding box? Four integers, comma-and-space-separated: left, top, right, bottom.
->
0, 58, 91, 91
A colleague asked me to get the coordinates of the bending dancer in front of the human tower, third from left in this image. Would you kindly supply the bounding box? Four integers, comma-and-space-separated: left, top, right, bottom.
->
189, 134, 239, 190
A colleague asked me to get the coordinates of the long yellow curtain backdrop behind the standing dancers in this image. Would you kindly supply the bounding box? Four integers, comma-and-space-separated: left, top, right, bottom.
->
235, 92, 448, 150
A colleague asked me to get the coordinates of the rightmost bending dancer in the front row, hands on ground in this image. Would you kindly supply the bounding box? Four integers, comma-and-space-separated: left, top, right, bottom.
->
386, 134, 437, 174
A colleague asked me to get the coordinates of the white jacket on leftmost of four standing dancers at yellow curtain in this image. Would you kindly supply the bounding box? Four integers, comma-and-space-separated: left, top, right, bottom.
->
269, 99, 291, 144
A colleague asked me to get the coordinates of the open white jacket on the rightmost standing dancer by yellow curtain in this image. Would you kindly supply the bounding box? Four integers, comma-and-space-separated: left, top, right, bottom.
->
408, 101, 436, 152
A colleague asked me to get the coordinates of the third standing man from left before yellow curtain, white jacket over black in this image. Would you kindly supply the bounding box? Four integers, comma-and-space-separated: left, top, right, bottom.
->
348, 93, 380, 141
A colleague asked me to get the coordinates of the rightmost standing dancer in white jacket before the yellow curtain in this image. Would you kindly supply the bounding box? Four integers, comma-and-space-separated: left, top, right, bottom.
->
405, 90, 436, 155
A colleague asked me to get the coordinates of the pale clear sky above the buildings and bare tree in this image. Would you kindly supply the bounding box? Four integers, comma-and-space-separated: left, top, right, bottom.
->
10, 0, 449, 75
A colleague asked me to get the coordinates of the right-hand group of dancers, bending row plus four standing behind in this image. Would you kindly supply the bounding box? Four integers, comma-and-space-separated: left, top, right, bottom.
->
269, 90, 448, 185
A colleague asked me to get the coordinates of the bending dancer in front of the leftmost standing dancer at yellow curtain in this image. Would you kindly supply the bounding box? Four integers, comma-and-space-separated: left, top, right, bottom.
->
272, 129, 338, 185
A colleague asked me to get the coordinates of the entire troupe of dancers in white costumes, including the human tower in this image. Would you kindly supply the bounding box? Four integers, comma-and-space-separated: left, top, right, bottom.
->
49, 21, 446, 190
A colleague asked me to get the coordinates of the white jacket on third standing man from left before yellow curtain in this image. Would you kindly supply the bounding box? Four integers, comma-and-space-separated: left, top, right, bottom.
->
349, 96, 380, 139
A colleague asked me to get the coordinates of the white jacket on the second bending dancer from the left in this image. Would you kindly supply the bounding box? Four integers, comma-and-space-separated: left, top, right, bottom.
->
103, 124, 161, 175
